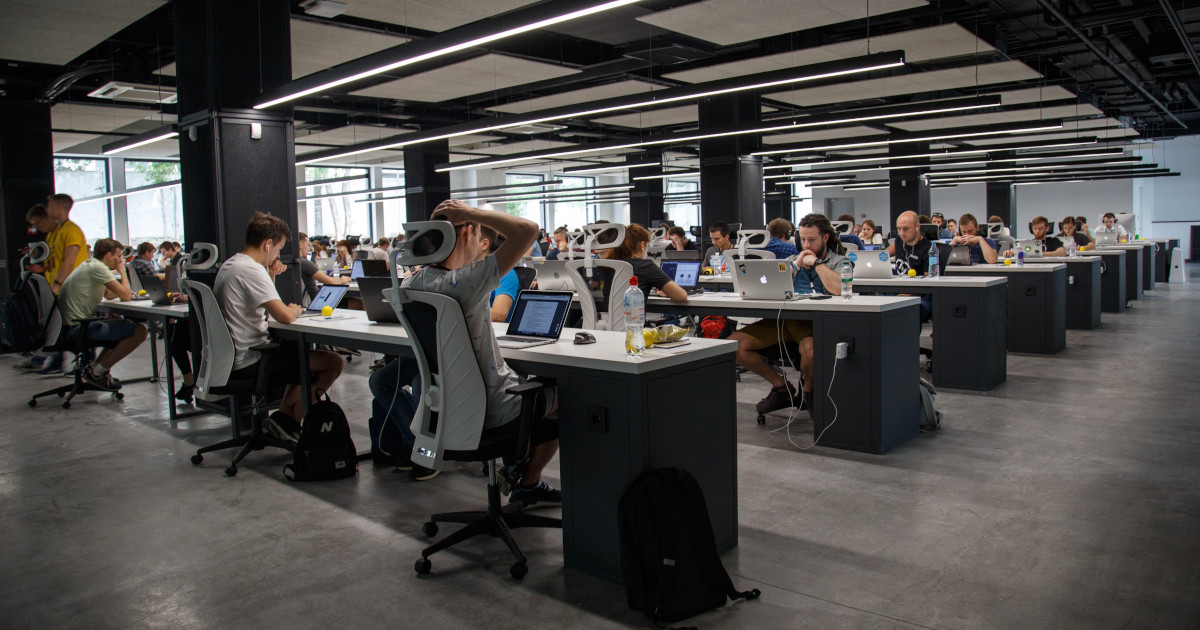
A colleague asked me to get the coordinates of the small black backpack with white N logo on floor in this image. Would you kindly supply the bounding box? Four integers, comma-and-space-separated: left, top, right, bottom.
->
283, 395, 359, 481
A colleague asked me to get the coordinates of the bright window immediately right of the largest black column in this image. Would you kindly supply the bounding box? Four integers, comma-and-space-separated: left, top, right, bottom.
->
304, 167, 374, 241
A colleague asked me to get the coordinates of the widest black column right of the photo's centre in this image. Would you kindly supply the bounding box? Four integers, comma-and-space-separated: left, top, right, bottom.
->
700, 95, 766, 230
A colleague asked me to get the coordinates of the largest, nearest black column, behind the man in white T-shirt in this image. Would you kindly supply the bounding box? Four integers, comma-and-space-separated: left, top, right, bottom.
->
175, 0, 300, 259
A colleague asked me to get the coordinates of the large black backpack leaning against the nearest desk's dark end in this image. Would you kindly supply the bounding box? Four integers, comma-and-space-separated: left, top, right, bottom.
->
617, 468, 761, 625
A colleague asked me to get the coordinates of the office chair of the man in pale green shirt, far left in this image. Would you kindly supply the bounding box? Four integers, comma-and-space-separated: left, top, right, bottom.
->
20, 242, 125, 409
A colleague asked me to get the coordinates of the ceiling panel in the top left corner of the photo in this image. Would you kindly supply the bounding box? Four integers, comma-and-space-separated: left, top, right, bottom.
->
0, 0, 166, 66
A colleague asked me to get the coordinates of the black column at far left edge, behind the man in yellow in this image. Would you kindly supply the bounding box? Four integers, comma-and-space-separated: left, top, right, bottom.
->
0, 98, 54, 295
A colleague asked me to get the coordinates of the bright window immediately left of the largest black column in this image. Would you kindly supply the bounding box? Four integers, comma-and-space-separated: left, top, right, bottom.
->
125, 160, 184, 246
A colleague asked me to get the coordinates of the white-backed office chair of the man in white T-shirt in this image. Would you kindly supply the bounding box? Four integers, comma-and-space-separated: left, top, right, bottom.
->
179, 248, 293, 476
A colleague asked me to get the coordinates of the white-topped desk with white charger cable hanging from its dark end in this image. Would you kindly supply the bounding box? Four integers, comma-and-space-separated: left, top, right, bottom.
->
646, 293, 920, 454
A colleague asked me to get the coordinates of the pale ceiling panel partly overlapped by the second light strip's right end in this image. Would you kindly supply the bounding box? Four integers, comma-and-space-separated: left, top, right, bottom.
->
664, 24, 995, 83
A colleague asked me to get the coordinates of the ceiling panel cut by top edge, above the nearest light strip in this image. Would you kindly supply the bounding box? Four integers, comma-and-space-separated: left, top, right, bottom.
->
346, 0, 535, 32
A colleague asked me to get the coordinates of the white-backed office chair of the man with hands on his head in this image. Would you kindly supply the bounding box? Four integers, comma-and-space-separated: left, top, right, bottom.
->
384, 221, 563, 580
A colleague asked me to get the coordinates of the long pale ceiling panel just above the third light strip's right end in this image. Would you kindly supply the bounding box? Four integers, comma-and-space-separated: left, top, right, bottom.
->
767, 61, 1042, 107
